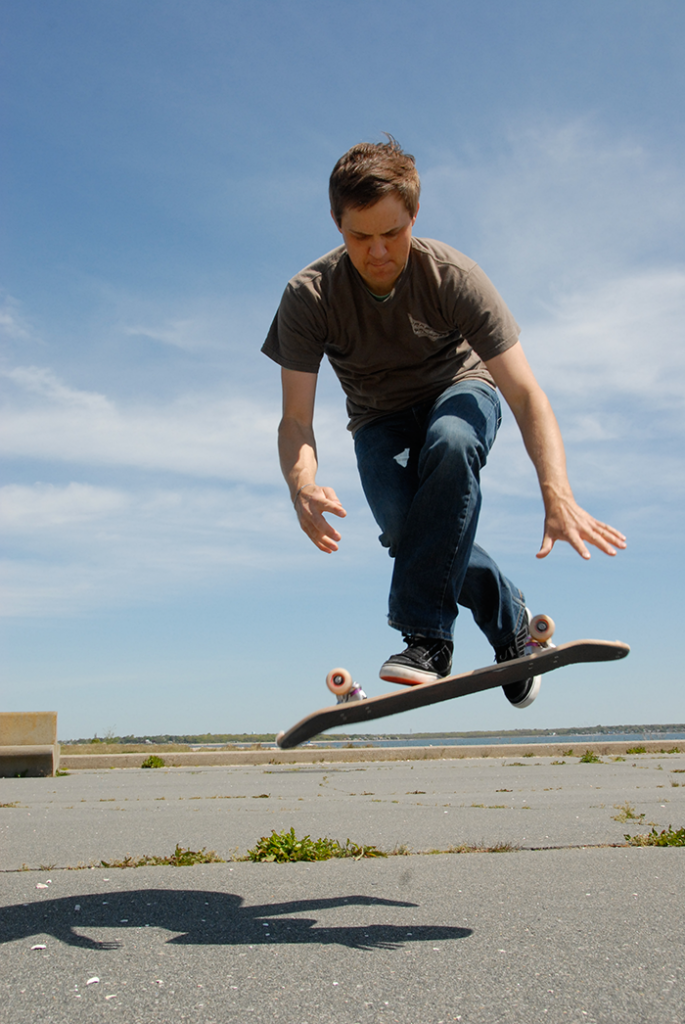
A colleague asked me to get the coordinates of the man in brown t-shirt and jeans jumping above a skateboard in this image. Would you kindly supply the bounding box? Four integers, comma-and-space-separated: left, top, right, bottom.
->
262, 136, 626, 708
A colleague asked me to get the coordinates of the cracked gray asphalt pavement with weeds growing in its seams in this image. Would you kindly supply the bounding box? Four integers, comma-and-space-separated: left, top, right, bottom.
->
0, 754, 685, 1024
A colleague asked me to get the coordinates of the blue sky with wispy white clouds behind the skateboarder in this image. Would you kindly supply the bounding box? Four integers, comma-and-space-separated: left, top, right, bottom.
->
0, 0, 685, 737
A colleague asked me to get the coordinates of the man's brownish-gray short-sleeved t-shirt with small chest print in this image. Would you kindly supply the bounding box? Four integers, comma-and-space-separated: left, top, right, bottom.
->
262, 239, 519, 431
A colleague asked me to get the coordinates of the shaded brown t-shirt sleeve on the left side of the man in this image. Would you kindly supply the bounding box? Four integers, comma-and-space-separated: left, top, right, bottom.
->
262, 283, 328, 374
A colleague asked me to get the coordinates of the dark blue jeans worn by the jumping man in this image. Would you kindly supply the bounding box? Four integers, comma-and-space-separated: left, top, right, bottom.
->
354, 380, 525, 646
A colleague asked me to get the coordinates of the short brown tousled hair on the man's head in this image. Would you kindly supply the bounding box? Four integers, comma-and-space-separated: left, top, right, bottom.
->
329, 132, 421, 227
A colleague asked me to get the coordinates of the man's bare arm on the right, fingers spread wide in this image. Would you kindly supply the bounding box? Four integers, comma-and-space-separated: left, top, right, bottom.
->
485, 342, 626, 558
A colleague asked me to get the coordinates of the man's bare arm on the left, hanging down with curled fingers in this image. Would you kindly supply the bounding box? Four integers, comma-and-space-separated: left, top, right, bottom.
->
279, 369, 347, 554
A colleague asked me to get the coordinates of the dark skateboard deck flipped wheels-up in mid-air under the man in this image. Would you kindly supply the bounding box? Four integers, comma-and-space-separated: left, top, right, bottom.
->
276, 640, 631, 750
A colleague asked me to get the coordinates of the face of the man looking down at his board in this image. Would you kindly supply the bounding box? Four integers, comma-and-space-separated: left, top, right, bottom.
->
331, 195, 418, 295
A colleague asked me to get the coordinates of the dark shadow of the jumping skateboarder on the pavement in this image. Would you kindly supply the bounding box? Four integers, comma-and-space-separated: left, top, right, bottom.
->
0, 889, 471, 950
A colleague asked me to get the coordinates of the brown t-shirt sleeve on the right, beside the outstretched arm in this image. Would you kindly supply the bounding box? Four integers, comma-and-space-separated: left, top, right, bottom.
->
453, 264, 520, 362
